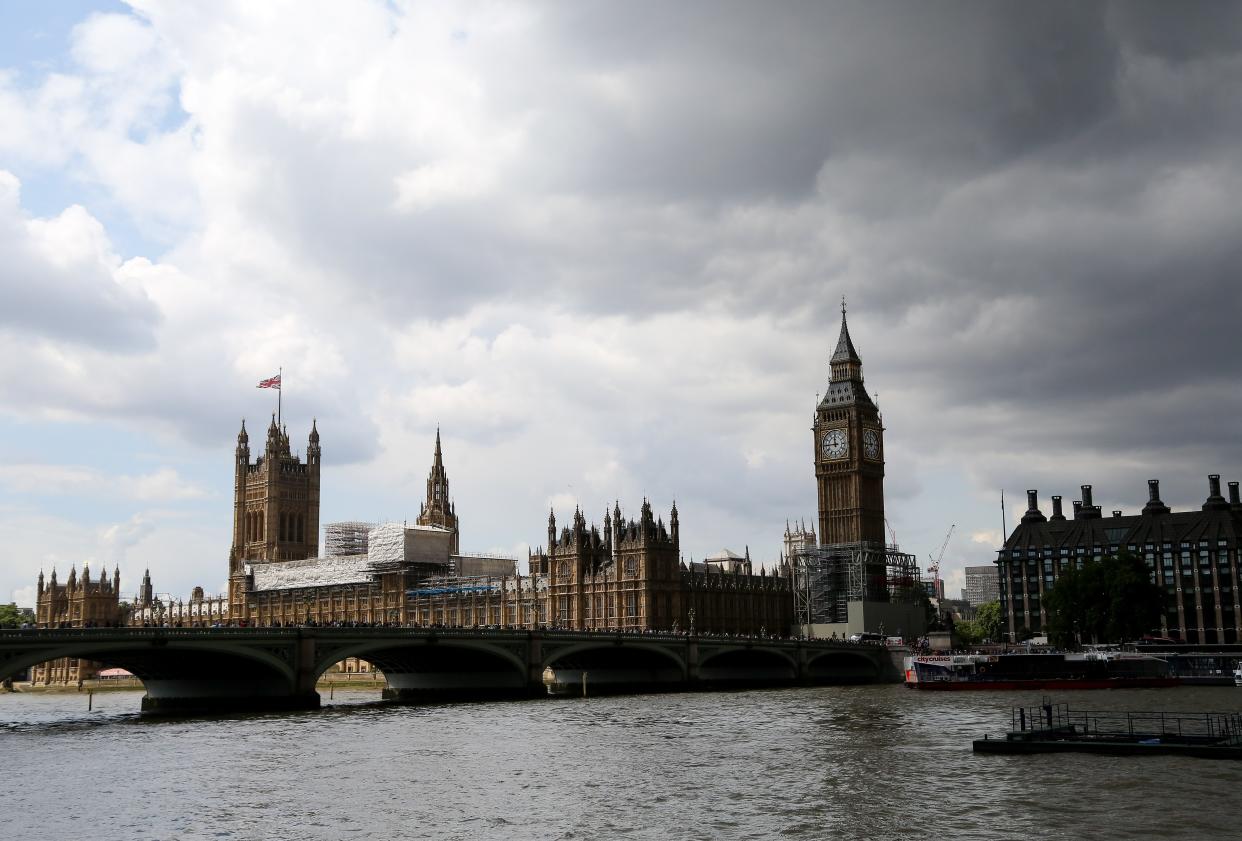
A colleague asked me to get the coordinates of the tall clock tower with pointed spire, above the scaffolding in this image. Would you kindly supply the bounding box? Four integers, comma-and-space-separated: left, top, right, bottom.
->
812, 301, 884, 547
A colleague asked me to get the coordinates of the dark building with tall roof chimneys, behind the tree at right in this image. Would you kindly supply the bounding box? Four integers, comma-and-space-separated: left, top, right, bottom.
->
996, 475, 1242, 643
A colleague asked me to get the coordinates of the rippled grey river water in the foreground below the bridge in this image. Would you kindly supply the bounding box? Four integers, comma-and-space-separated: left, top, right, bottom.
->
0, 686, 1242, 841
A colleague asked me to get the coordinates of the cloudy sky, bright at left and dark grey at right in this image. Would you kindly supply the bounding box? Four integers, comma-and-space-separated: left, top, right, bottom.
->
0, 0, 1242, 605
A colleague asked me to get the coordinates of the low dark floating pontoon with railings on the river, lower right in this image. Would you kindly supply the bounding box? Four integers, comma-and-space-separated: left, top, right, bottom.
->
972, 699, 1242, 759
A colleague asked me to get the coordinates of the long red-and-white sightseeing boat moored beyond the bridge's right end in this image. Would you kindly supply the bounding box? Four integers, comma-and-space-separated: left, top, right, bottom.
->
905, 651, 1181, 691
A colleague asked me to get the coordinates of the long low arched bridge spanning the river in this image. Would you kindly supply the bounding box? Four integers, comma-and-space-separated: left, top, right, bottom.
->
0, 627, 902, 714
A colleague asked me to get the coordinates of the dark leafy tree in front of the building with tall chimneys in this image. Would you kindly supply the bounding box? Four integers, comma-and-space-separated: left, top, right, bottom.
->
1043, 552, 1165, 648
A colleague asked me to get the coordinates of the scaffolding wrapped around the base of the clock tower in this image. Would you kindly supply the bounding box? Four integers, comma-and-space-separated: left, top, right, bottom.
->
794, 542, 923, 625
